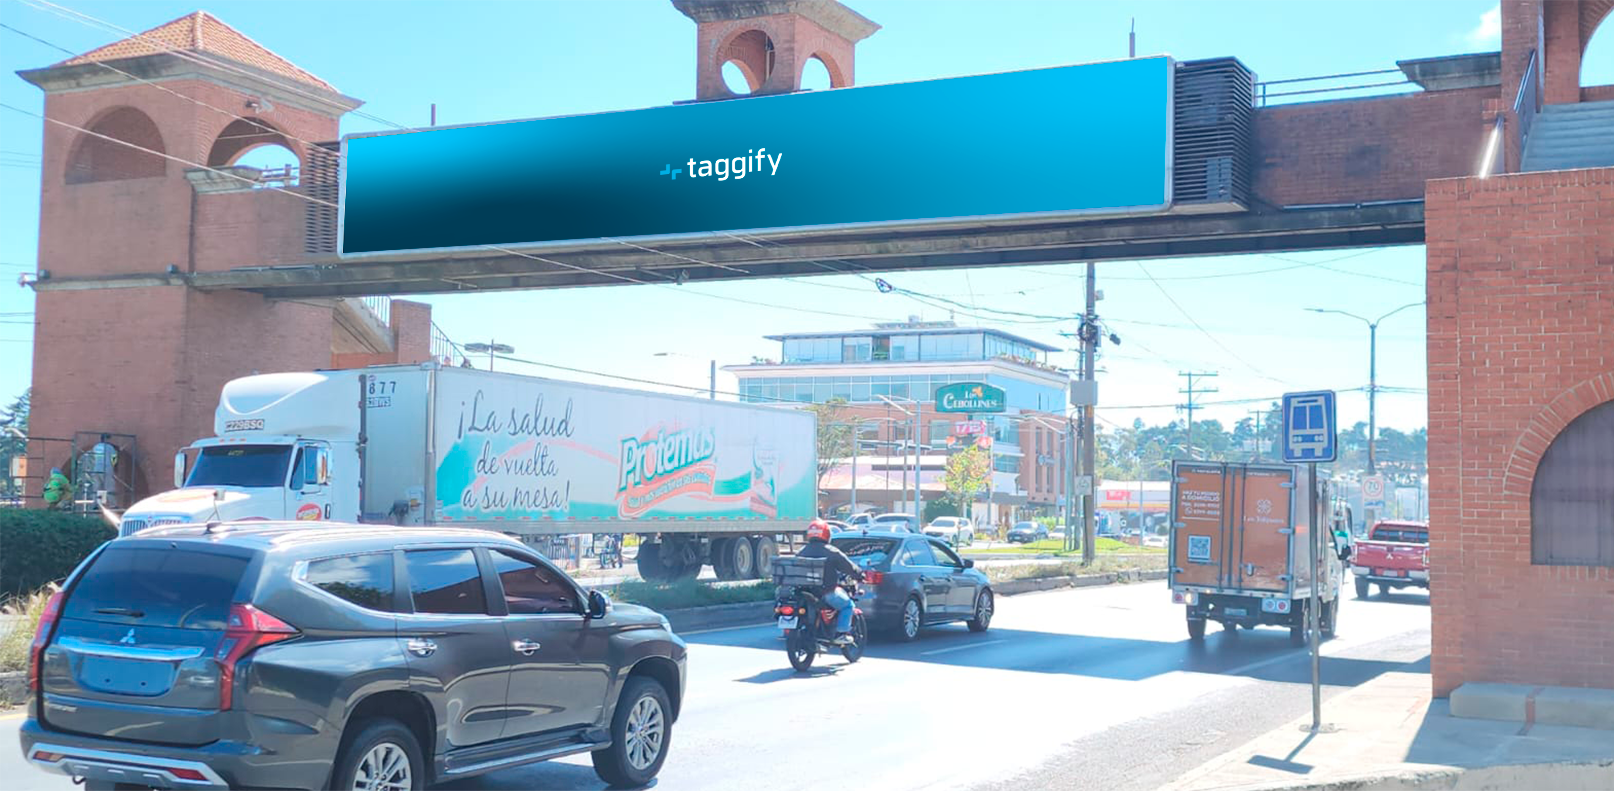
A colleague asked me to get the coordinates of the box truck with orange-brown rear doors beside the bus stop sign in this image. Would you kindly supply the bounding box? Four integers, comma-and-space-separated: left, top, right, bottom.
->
1167, 462, 1348, 644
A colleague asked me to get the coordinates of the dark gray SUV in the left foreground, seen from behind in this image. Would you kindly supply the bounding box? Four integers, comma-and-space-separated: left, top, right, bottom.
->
21, 521, 684, 791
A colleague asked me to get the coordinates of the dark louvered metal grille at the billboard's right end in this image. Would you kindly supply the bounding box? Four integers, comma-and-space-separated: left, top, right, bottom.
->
1172, 58, 1256, 207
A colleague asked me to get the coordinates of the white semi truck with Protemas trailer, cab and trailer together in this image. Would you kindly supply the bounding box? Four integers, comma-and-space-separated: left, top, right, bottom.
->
119, 363, 818, 581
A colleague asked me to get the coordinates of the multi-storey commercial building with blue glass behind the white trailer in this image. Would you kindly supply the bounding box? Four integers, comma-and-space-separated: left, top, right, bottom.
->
725, 316, 1070, 523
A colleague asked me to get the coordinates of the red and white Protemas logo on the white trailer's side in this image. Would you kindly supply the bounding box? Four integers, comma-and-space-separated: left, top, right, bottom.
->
617, 428, 717, 517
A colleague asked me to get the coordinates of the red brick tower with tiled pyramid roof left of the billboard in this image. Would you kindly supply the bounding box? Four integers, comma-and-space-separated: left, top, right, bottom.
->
21, 13, 431, 507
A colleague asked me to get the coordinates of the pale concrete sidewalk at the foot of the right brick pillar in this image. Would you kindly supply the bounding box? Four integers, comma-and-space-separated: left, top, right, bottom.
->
1165, 672, 1614, 791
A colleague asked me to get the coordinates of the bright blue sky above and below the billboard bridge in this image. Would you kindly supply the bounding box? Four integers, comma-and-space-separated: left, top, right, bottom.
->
0, 0, 1614, 429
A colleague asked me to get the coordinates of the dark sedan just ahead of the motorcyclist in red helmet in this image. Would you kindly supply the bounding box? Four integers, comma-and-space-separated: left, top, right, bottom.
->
831, 531, 996, 641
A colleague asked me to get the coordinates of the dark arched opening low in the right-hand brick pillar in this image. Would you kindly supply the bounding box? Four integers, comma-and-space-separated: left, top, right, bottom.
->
1530, 402, 1614, 567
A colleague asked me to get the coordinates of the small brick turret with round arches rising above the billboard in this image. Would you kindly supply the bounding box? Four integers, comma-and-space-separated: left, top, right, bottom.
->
673, 0, 880, 102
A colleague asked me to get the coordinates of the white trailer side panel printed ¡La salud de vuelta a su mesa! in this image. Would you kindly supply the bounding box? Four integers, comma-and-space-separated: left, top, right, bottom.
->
434, 371, 815, 523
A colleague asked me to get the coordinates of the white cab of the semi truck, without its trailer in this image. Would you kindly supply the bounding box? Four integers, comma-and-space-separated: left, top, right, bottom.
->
118, 371, 360, 536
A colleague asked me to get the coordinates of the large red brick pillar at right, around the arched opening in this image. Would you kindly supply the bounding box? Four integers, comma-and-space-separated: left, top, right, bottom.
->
1425, 168, 1614, 696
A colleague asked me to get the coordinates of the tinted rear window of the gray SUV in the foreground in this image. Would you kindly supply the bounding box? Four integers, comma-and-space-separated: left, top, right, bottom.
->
61, 541, 250, 630
